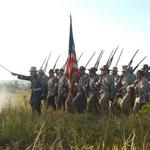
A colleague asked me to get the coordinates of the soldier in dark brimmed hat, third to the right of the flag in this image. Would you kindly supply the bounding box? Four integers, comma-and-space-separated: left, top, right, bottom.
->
99, 65, 115, 111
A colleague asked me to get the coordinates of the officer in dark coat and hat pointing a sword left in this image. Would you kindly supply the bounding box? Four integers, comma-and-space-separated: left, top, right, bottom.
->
12, 67, 43, 114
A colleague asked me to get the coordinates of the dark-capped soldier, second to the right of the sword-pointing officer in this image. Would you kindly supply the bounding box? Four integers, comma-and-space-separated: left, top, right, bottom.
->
47, 69, 58, 110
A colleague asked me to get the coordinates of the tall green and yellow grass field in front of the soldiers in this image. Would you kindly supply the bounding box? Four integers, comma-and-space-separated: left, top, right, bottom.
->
0, 89, 150, 150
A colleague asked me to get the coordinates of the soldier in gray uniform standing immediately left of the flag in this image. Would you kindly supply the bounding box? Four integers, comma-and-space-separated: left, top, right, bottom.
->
57, 69, 68, 110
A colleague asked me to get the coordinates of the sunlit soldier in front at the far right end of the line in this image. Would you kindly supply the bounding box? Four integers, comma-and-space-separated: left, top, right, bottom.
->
134, 70, 149, 113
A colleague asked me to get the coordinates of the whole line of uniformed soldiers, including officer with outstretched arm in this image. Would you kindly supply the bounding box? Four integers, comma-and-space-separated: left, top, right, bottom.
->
12, 64, 150, 115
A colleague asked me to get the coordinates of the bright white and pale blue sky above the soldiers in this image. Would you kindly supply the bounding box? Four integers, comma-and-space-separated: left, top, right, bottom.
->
0, 0, 150, 80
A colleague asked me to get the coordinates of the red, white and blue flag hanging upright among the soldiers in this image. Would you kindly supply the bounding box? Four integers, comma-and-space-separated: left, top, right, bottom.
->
66, 15, 78, 82
